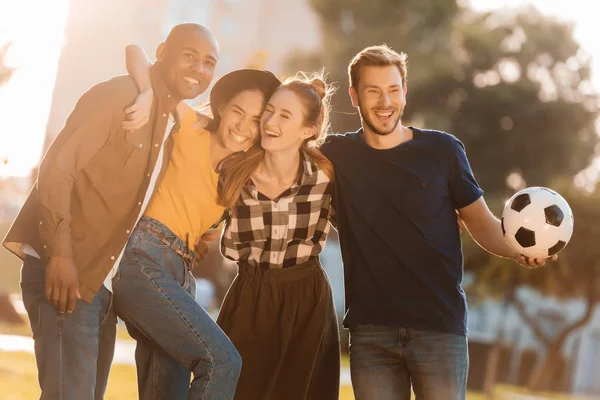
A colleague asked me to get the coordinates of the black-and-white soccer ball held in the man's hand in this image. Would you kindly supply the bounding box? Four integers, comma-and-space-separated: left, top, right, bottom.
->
502, 187, 573, 258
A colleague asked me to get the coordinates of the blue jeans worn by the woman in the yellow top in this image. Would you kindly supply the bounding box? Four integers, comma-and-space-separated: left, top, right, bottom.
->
113, 217, 242, 400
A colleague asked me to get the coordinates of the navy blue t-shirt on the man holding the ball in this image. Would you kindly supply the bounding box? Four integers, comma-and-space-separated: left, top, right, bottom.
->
321, 127, 483, 335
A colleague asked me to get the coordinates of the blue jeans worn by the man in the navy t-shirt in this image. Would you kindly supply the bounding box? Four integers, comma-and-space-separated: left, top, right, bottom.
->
350, 325, 469, 400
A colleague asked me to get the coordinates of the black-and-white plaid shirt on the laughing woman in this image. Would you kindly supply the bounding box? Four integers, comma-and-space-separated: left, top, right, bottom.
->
221, 152, 333, 269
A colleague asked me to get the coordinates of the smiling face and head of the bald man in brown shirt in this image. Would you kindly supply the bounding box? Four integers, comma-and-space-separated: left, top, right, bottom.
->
156, 25, 219, 100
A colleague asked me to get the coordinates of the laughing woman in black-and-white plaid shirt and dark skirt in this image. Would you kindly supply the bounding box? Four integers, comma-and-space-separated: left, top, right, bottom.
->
217, 72, 340, 400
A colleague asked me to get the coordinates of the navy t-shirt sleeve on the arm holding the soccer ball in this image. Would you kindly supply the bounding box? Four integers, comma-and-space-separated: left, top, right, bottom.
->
449, 139, 483, 209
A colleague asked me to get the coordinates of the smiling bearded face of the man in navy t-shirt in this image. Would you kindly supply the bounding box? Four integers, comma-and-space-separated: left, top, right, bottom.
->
350, 65, 406, 136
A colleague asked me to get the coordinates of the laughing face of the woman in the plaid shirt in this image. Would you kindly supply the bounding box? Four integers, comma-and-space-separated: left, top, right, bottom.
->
260, 88, 315, 152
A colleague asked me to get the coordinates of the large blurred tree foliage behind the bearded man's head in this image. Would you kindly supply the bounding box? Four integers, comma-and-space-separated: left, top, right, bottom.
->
287, 0, 600, 195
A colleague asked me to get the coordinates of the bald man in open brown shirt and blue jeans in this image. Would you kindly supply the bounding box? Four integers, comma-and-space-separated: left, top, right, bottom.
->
3, 24, 219, 400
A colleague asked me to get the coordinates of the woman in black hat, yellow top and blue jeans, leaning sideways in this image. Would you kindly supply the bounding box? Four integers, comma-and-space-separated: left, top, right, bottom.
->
116, 43, 281, 399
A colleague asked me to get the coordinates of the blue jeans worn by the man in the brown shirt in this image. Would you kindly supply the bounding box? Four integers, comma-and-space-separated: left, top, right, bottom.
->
21, 257, 117, 400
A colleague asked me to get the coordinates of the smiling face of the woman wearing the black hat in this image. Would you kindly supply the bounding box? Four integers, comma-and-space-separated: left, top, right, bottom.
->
216, 90, 264, 152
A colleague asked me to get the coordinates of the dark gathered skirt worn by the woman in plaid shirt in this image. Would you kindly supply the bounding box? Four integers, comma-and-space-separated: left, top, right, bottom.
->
217, 259, 340, 400
